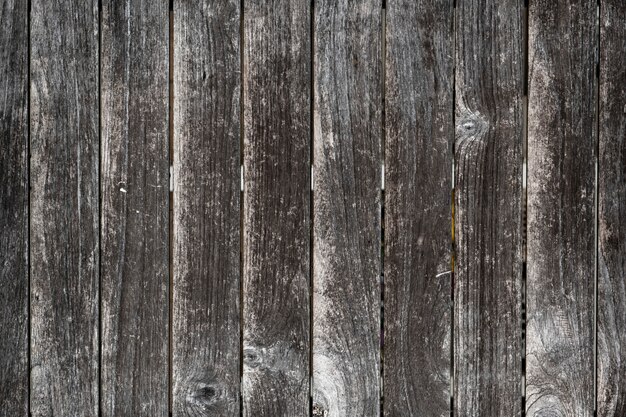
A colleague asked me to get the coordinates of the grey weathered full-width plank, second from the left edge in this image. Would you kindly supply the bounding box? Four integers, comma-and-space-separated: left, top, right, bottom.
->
30, 0, 100, 417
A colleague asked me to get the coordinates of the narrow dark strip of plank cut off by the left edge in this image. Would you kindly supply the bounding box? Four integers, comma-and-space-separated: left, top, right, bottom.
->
0, 0, 29, 417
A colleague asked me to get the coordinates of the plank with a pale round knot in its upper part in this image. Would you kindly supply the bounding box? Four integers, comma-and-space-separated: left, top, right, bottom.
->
454, 0, 524, 416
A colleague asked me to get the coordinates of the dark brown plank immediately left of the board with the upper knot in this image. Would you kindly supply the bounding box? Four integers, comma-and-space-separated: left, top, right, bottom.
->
383, 0, 454, 417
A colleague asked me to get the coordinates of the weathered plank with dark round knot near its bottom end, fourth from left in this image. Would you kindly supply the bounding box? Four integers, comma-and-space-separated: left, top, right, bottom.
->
172, 0, 241, 416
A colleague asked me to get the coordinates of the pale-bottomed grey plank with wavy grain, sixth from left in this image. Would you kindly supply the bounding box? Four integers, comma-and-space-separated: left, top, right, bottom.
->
312, 0, 382, 417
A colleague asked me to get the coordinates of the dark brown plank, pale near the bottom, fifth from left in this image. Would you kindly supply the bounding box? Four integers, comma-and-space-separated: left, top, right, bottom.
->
242, 0, 311, 417
